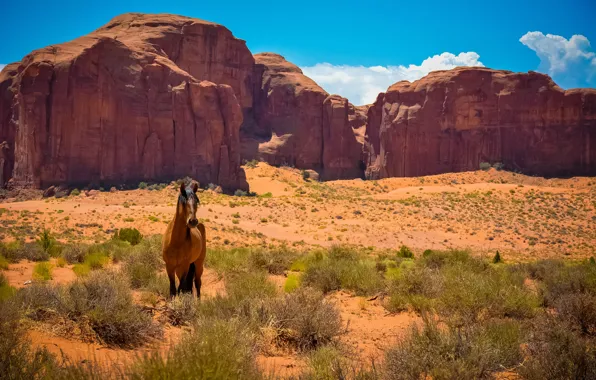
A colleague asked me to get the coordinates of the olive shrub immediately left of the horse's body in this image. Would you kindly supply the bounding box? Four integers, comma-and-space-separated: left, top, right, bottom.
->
123, 237, 164, 288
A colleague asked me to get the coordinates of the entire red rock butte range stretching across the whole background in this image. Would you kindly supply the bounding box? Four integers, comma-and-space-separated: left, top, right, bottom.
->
0, 14, 596, 190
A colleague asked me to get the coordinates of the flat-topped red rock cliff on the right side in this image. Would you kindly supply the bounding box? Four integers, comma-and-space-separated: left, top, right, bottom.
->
366, 68, 596, 178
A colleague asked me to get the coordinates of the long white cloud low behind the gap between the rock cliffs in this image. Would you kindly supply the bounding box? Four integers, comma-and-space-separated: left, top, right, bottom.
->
301, 52, 484, 105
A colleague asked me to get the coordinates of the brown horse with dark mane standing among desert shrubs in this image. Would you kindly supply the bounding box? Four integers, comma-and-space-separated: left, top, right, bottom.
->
162, 182, 207, 297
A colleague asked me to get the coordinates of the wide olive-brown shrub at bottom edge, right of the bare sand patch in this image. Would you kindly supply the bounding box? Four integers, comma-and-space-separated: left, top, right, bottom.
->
385, 319, 523, 380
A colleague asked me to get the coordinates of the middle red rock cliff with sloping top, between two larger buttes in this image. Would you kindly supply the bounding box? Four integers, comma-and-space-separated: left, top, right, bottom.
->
243, 53, 363, 179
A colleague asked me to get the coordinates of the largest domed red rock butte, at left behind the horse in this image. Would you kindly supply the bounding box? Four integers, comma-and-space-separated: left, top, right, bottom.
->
0, 14, 249, 189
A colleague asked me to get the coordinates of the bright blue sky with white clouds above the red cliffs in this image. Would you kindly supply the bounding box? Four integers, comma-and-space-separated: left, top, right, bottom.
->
0, 0, 596, 103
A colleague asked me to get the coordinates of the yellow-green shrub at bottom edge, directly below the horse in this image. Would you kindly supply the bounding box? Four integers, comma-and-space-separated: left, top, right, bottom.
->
129, 319, 262, 380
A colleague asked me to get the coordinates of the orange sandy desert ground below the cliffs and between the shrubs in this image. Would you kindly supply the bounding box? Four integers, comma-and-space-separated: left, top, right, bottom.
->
0, 163, 596, 376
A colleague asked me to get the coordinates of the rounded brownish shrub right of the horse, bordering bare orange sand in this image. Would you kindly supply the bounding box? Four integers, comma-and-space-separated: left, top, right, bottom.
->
270, 288, 342, 350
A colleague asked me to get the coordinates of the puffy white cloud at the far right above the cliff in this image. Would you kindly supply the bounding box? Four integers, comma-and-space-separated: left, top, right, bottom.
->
519, 32, 596, 81
